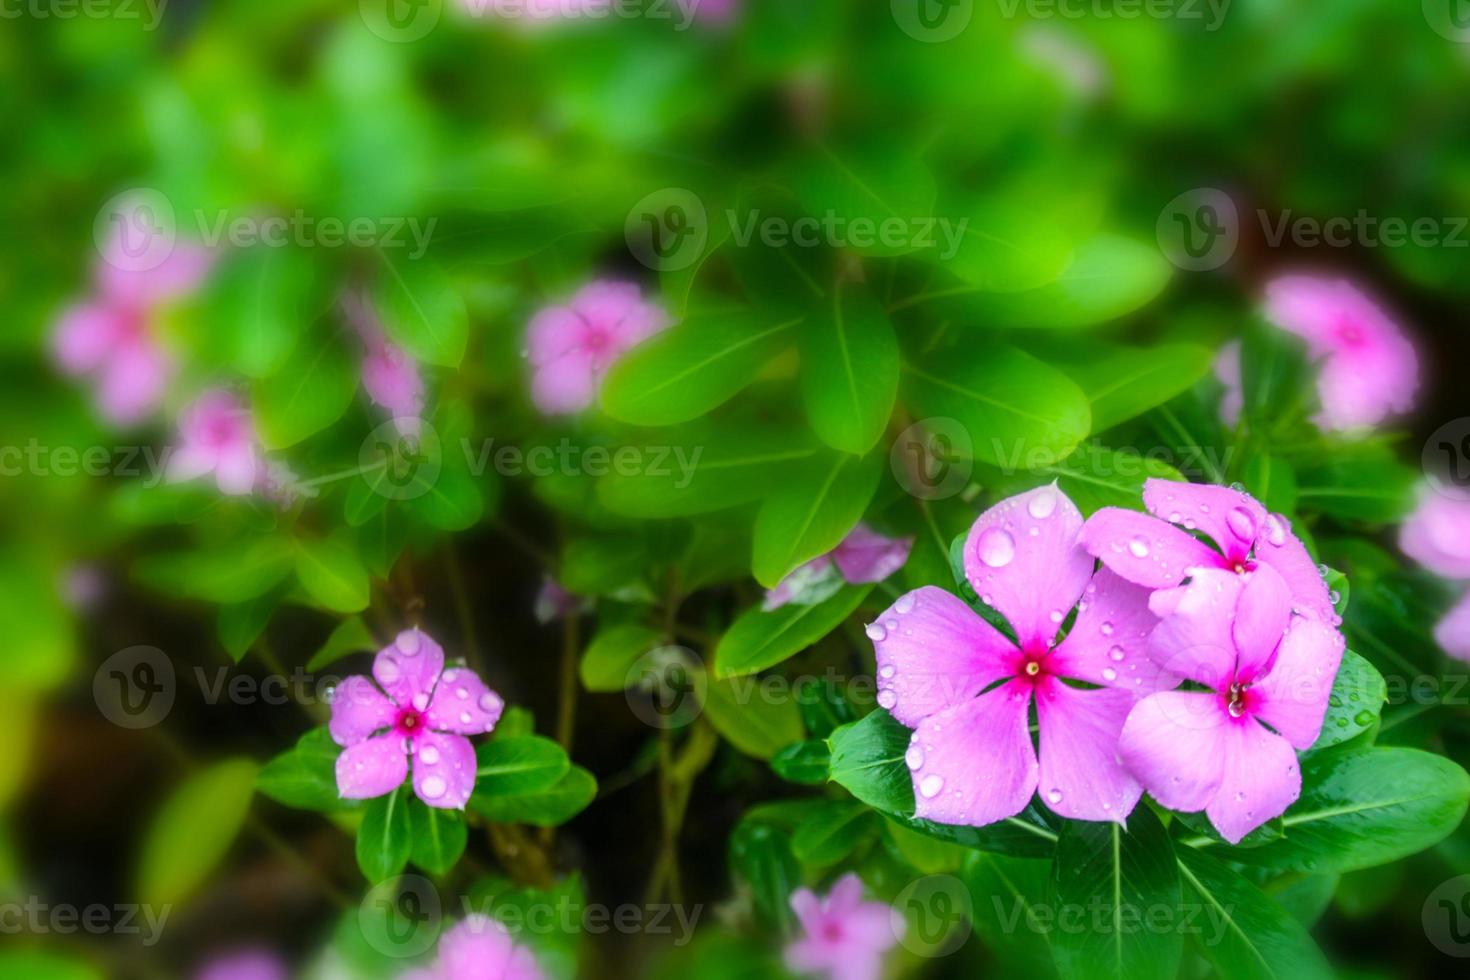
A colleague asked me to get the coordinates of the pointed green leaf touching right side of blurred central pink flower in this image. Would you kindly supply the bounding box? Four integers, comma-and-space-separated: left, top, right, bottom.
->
601, 310, 800, 426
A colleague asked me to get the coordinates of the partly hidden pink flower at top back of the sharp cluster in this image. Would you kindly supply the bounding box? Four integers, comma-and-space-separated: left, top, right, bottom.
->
1080, 479, 1338, 624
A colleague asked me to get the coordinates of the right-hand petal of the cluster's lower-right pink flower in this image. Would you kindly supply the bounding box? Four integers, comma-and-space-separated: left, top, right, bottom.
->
1251, 619, 1345, 751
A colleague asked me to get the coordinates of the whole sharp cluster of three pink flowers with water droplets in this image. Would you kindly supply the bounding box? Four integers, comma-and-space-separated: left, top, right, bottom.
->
867, 480, 1344, 842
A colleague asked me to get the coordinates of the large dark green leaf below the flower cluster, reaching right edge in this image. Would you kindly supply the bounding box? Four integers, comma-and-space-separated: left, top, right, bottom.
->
1191, 748, 1470, 873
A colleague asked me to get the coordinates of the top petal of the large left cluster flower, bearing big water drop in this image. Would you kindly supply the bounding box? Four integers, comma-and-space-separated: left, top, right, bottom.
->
964, 483, 1092, 649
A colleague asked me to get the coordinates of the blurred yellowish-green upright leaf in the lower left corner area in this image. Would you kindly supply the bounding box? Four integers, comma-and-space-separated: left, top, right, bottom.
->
138, 758, 257, 905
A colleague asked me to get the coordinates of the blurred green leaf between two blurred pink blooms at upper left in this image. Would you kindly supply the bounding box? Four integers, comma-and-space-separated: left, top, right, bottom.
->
251, 329, 357, 450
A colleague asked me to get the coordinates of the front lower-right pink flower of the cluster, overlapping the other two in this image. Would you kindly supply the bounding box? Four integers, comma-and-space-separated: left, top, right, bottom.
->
1117, 564, 1344, 843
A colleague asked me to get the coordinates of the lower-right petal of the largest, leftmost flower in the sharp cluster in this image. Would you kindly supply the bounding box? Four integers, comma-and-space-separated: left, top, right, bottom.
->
1036, 677, 1144, 823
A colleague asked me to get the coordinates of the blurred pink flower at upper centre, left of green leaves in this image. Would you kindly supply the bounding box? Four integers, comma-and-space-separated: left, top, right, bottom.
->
526, 279, 669, 416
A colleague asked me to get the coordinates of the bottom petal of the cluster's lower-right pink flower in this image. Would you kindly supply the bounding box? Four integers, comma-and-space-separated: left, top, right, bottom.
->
1205, 717, 1301, 843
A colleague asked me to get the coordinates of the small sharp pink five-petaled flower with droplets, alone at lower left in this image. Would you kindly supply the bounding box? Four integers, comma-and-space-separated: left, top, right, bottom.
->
328, 629, 506, 810
